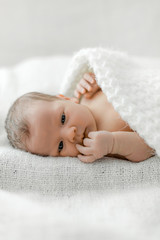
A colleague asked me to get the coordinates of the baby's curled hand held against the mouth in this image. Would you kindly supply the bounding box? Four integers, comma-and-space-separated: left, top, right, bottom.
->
76, 131, 114, 163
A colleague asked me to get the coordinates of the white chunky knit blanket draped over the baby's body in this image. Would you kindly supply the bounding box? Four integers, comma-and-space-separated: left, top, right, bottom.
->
61, 48, 160, 156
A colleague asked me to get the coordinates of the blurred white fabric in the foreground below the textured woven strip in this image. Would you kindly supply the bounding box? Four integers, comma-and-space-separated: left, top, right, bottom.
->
0, 187, 160, 240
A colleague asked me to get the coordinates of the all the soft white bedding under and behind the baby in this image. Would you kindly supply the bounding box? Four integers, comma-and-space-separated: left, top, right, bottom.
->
0, 53, 160, 240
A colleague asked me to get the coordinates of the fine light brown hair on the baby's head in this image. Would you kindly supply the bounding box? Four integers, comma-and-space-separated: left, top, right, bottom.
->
5, 92, 61, 151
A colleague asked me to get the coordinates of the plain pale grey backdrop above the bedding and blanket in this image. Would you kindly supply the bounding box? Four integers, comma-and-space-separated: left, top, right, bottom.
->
0, 0, 160, 66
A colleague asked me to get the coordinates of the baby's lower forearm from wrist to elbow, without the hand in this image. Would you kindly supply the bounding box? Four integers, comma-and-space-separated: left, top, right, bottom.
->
111, 131, 154, 162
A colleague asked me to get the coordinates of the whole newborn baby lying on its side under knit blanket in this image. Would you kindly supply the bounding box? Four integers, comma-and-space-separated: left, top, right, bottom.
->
5, 73, 154, 163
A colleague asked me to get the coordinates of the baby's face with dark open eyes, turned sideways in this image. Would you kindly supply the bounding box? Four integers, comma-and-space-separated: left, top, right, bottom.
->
26, 100, 97, 157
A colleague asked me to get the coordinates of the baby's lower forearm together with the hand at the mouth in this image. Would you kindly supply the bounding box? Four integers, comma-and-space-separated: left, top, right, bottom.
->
76, 131, 155, 163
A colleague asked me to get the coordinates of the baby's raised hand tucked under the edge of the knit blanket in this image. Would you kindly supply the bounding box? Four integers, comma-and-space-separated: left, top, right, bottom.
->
74, 72, 100, 98
